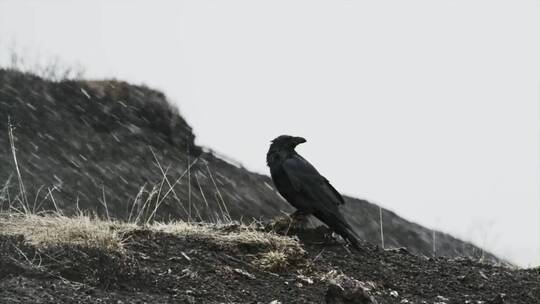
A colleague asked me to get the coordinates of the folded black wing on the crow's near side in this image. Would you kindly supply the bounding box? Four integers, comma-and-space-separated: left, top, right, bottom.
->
282, 155, 345, 205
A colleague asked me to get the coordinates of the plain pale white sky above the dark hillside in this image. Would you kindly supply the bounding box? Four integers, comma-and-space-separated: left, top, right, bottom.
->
0, 0, 540, 266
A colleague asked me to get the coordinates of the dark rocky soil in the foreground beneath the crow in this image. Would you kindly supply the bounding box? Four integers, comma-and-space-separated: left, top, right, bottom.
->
0, 215, 540, 304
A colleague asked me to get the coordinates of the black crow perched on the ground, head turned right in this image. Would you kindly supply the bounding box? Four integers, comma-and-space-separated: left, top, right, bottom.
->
266, 135, 360, 247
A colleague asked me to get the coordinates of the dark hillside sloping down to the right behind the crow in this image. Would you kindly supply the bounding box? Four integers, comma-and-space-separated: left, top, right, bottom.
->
0, 69, 497, 261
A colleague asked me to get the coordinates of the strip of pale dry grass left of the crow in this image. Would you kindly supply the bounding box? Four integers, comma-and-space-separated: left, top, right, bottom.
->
0, 213, 304, 271
